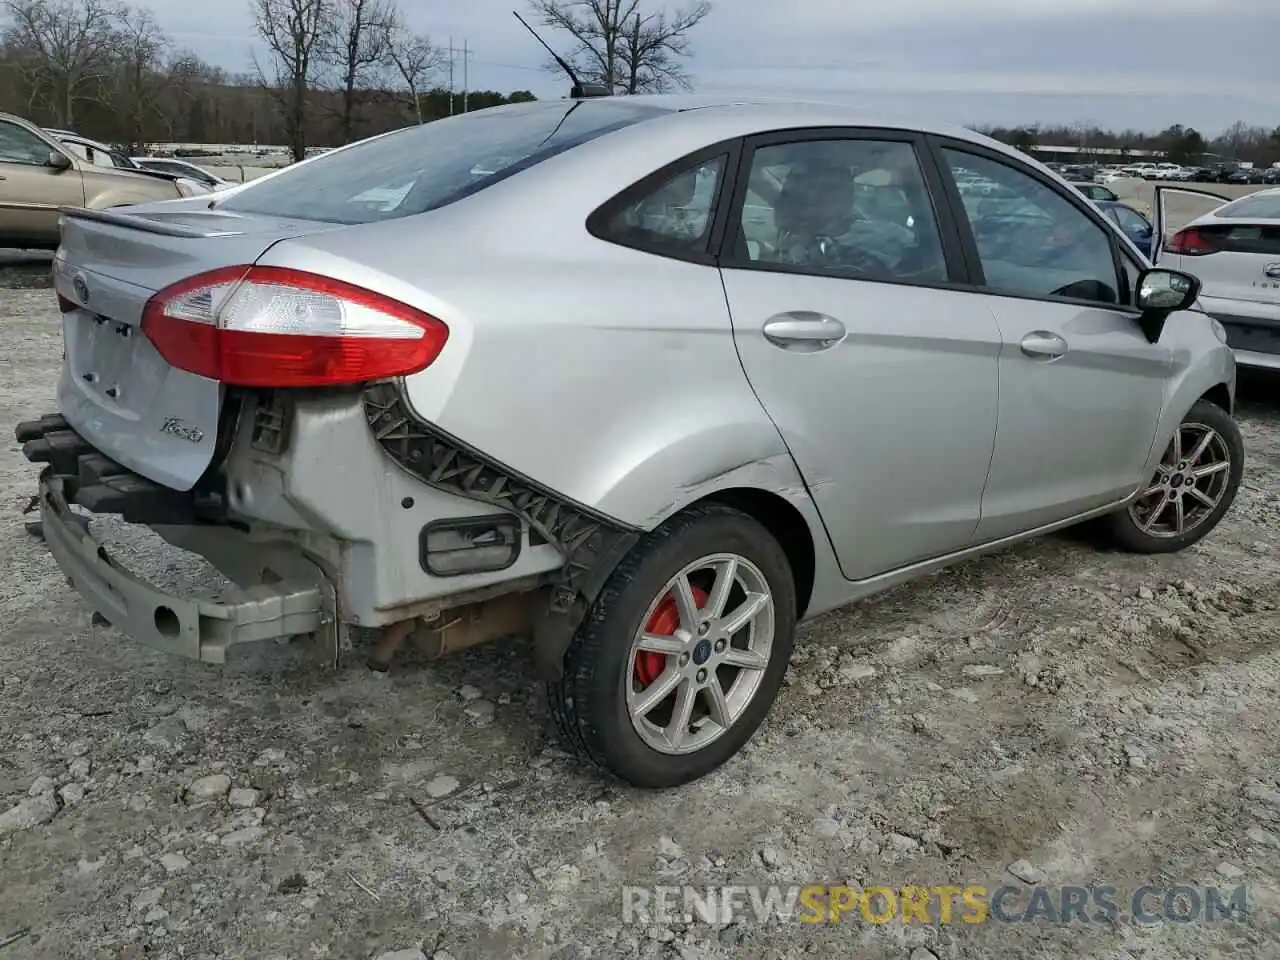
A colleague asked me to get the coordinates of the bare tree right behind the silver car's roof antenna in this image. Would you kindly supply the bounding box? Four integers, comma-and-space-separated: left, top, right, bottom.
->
531, 0, 712, 93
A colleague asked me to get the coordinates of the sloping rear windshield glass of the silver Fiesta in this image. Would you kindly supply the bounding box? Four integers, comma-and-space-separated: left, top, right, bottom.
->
218, 100, 666, 224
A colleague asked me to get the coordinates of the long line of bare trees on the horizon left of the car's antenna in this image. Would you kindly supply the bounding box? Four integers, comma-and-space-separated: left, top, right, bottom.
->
0, 0, 710, 159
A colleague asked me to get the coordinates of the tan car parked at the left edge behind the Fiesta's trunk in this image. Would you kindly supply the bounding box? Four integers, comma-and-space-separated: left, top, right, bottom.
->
0, 114, 188, 250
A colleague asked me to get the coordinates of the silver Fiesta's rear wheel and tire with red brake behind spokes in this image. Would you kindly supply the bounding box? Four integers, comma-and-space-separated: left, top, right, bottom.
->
548, 504, 796, 790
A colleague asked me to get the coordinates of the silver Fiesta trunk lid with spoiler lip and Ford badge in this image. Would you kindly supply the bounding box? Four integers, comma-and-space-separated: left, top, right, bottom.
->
54, 207, 334, 490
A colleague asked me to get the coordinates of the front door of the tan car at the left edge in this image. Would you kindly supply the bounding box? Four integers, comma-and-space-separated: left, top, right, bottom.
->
0, 120, 84, 243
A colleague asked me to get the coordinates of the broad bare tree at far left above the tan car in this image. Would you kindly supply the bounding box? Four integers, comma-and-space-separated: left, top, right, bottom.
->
4, 0, 120, 127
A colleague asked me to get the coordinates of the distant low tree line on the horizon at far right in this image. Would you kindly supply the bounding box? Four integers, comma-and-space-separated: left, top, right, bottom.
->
974, 120, 1280, 166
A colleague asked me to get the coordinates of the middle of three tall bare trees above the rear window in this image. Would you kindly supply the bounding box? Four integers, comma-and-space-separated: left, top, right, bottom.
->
321, 0, 396, 143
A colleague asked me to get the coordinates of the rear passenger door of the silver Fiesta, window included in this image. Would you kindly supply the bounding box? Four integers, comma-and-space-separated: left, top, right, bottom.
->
719, 131, 1000, 580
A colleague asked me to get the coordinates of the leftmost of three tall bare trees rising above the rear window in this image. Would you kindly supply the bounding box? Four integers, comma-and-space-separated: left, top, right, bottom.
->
251, 0, 330, 160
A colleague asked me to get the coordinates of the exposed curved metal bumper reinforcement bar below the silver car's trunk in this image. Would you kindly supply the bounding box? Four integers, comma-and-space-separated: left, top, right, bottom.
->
38, 467, 337, 663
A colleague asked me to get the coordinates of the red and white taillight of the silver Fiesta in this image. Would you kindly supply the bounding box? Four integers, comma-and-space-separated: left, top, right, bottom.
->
142, 266, 449, 388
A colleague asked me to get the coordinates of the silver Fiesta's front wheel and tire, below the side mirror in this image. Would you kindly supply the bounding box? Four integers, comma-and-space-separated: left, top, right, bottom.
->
1106, 401, 1244, 553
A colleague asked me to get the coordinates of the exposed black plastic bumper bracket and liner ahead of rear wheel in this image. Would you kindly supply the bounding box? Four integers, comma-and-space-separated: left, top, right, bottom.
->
364, 381, 643, 680
